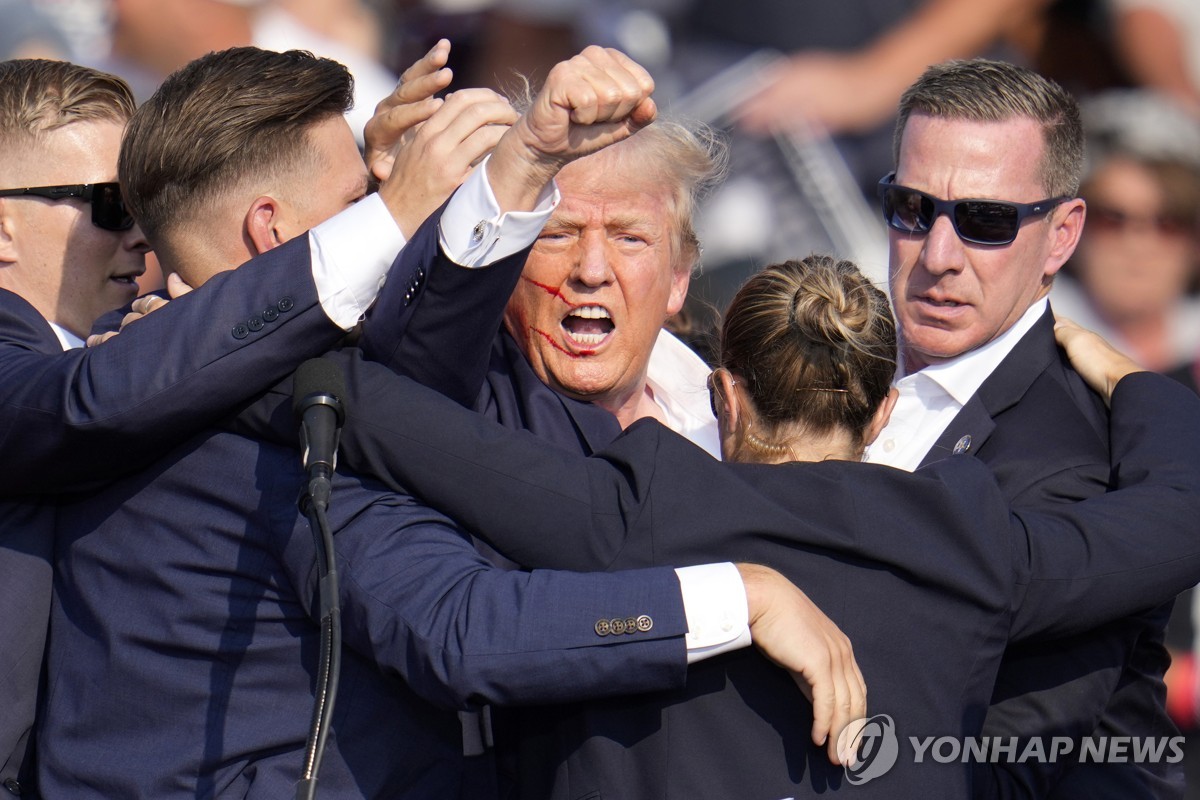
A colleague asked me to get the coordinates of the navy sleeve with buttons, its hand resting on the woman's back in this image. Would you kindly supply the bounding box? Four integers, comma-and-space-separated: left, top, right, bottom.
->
272, 477, 688, 708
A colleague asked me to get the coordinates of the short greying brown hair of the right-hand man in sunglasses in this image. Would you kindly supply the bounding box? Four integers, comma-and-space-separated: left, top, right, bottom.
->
892, 59, 1084, 197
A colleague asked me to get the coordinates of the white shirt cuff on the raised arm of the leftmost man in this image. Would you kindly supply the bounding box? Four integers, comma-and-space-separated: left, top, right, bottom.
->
308, 194, 406, 331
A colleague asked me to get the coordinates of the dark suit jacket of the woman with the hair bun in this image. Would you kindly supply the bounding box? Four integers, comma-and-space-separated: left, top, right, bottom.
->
267, 365, 1200, 798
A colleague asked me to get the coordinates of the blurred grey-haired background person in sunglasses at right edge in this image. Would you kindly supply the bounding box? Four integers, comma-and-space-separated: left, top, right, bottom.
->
1051, 91, 1200, 372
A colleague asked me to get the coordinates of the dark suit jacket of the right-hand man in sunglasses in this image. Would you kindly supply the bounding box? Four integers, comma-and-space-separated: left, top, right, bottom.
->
924, 311, 1183, 800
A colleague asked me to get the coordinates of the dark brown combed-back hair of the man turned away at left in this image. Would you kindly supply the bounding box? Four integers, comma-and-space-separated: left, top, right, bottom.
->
120, 47, 354, 241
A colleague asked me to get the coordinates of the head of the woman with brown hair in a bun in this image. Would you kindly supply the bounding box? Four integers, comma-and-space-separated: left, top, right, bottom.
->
710, 255, 896, 463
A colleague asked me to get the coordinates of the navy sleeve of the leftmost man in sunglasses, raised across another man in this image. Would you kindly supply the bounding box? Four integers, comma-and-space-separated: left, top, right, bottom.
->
0, 236, 344, 495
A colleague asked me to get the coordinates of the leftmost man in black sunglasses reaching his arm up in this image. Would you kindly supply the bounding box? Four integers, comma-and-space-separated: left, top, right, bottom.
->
0, 53, 528, 796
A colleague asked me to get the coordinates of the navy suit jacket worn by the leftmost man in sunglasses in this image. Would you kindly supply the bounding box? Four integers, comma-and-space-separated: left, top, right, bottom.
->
0, 236, 355, 795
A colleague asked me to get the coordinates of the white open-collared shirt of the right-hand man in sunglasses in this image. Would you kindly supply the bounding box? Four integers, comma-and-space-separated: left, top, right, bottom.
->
866, 297, 1049, 473
